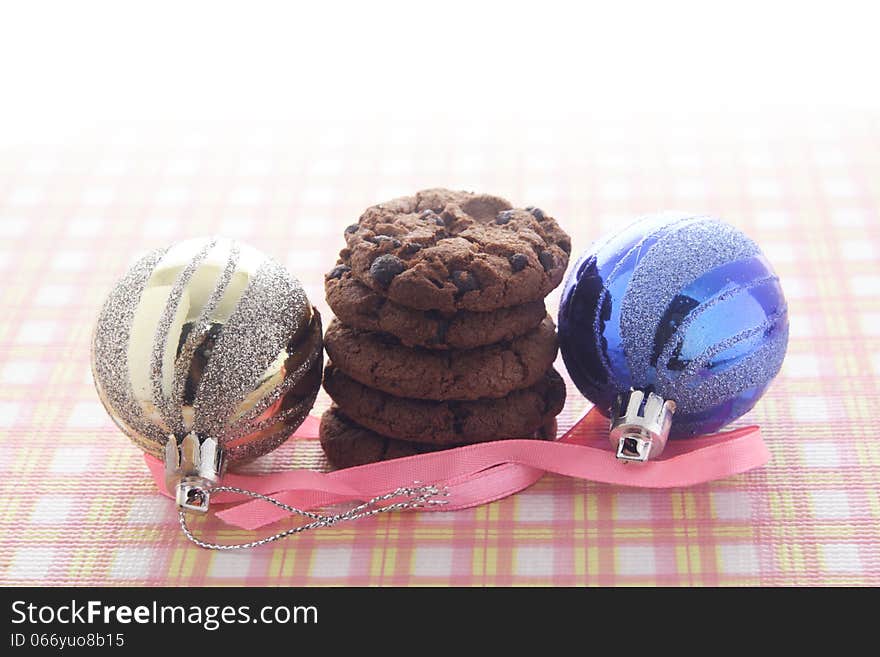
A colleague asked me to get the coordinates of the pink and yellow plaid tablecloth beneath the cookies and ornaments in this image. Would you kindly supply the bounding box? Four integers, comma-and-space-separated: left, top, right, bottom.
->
0, 114, 880, 586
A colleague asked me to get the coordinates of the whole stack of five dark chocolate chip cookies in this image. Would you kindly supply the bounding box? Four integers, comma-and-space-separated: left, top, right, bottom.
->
321, 189, 571, 467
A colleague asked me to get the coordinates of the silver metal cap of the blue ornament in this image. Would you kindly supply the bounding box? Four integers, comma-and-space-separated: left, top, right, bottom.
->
610, 390, 675, 463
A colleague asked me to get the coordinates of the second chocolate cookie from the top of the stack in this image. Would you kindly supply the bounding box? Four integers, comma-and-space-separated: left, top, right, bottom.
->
324, 263, 547, 349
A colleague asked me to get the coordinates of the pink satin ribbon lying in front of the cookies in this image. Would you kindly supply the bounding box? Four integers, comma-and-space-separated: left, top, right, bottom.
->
145, 409, 770, 530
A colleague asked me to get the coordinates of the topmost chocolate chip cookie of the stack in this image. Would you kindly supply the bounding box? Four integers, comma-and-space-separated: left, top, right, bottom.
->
341, 189, 571, 313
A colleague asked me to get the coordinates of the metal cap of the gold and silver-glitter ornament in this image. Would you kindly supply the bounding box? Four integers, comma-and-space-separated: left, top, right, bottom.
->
165, 431, 225, 513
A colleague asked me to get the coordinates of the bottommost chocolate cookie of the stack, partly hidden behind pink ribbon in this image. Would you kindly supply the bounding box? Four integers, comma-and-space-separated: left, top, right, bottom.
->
320, 406, 556, 468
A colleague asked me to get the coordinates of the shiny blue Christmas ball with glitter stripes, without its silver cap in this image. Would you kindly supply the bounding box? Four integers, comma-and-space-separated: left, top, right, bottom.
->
559, 213, 788, 437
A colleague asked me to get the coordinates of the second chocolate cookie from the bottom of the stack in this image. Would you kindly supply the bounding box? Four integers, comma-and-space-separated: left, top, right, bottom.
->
324, 364, 565, 446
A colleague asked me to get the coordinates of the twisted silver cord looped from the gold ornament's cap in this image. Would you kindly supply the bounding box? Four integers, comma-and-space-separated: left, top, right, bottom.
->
178, 485, 449, 550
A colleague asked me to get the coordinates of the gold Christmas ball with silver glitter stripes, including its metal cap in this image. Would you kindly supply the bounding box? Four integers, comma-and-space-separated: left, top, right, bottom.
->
92, 238, 323, 511
